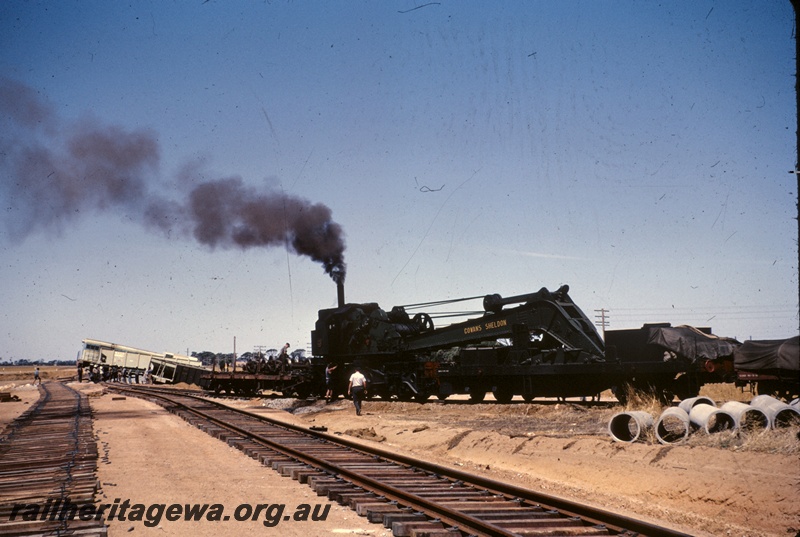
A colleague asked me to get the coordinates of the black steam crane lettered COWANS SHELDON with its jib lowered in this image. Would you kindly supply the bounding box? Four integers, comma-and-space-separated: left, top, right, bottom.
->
312, 285, 610, 401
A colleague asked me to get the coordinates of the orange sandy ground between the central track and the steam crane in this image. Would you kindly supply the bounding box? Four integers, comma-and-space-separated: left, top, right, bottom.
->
220, 390, 800, 537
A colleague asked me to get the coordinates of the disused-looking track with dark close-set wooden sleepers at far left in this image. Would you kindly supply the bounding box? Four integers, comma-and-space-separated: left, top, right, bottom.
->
0, 382, 106, 537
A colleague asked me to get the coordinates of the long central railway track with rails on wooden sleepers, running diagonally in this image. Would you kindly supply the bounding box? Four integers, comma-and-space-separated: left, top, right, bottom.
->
108, 385, 686, 537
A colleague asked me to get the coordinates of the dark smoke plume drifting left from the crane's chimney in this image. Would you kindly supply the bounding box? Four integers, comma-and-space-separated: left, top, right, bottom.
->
0, 78, 345, 282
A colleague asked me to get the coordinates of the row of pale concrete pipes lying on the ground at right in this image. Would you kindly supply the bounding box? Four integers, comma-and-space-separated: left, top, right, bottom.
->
608, 395, 800, 444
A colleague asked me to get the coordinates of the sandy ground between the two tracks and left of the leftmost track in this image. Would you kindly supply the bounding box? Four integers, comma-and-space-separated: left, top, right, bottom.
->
0, 383, 391, 537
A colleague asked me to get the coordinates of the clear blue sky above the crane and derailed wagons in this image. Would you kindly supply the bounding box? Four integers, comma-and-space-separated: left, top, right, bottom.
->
0, 0, 798, 359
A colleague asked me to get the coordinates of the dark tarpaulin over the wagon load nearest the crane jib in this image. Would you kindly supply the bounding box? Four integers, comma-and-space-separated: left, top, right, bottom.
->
647, 326, 741, 362
